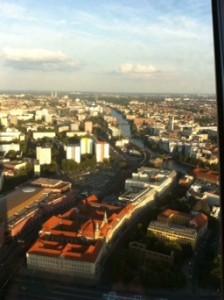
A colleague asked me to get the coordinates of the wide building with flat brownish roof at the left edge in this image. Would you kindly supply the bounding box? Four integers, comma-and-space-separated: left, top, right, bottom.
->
0, 178, 72, 237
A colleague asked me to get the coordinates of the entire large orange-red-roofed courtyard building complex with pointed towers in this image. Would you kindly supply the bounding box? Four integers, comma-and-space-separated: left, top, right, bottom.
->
27, 196, 140, 280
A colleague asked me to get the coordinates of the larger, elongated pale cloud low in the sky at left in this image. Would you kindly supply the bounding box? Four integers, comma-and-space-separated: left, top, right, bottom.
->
3, 48, 78, 71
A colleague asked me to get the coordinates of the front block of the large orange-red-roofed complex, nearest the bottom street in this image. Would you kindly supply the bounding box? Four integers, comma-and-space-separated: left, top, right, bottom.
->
26, 236, 105, 280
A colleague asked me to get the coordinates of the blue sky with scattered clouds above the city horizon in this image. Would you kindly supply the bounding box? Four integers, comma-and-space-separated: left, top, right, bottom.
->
0, 0, 215, 94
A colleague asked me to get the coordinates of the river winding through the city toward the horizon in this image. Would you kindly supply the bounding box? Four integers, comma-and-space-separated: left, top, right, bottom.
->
111, 110, 192, 174
